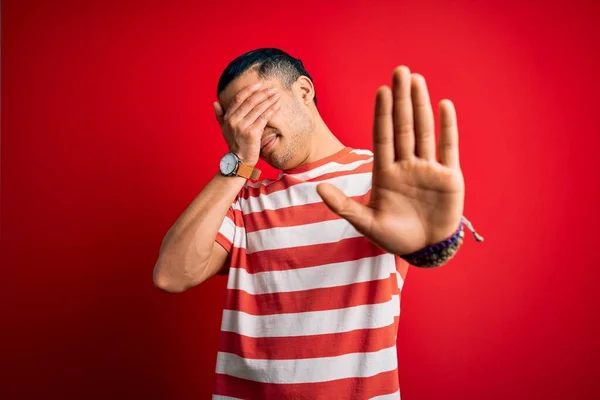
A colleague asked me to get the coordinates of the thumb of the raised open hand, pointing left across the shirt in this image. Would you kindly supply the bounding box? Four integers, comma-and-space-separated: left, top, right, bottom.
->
317, 183, 373, 235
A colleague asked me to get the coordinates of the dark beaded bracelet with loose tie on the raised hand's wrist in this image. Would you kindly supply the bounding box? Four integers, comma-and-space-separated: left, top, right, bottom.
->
402, 216, 483, 268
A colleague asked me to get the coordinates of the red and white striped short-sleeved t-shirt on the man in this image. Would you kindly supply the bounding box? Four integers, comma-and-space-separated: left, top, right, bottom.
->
213, 147, 408, 400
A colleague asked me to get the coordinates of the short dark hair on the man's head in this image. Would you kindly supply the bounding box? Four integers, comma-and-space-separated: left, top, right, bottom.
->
217, 48, 317, 105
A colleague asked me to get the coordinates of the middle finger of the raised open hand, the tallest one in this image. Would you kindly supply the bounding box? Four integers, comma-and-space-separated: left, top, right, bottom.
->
393, 66, 415, 160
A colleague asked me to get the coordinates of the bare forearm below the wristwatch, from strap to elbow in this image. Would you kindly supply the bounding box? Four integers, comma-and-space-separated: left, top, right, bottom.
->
154, 175, 246, 290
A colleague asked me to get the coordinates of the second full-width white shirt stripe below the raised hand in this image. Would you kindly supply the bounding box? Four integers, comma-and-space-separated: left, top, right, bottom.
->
221, 295, 400, 338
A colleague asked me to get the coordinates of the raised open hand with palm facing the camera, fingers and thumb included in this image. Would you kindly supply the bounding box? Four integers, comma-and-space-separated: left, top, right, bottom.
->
317, 66, 465, 255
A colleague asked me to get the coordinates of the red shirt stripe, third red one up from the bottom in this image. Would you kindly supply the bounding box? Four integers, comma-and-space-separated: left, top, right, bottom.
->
225, 274, 398, 315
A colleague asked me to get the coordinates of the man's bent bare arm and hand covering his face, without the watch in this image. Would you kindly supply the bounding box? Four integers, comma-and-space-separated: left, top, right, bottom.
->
153, 85, 279, 293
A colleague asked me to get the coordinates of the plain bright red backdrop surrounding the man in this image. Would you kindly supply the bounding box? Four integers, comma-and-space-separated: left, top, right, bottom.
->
0, 0, 600, 400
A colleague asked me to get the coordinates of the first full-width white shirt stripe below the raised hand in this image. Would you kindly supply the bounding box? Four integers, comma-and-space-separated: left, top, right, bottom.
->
227, 254, 399, 294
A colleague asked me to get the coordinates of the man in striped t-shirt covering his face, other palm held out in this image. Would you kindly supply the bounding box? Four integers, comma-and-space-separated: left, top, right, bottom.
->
154, 49, 479, 400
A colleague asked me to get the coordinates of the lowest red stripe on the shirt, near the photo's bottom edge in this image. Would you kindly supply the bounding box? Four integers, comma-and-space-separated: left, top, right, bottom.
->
215, 369, 398, 400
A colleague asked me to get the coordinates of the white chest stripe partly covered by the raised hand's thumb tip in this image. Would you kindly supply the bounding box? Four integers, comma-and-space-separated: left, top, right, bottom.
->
232, 172, 372, 214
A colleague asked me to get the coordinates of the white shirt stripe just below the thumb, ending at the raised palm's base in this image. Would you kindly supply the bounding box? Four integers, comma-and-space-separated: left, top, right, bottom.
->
247, 218, 362, 254
